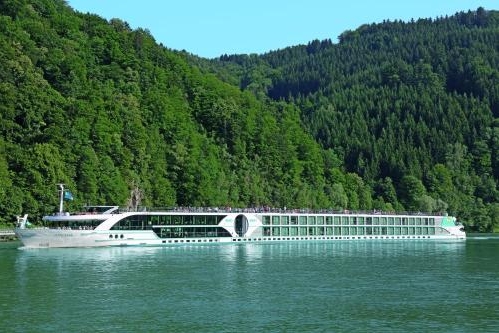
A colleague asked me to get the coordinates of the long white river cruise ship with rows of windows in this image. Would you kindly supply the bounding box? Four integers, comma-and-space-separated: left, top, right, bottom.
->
15, 189, 466, 248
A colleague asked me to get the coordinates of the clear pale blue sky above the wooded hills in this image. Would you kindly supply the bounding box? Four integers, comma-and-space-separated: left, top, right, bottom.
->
67, 0, 499, 58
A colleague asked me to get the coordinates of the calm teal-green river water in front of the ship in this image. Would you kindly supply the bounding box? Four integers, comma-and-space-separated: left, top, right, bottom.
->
0, 237, 499, 332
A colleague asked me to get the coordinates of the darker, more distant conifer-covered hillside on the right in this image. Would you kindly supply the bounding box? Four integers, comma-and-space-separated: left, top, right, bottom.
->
211, 8, 499, 230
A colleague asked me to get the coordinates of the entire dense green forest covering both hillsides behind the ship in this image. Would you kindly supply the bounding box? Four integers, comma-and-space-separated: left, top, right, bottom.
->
0, 0, 499, 231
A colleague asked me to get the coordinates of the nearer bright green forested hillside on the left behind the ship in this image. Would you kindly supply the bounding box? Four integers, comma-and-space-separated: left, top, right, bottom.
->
0, 0, 340, 222
